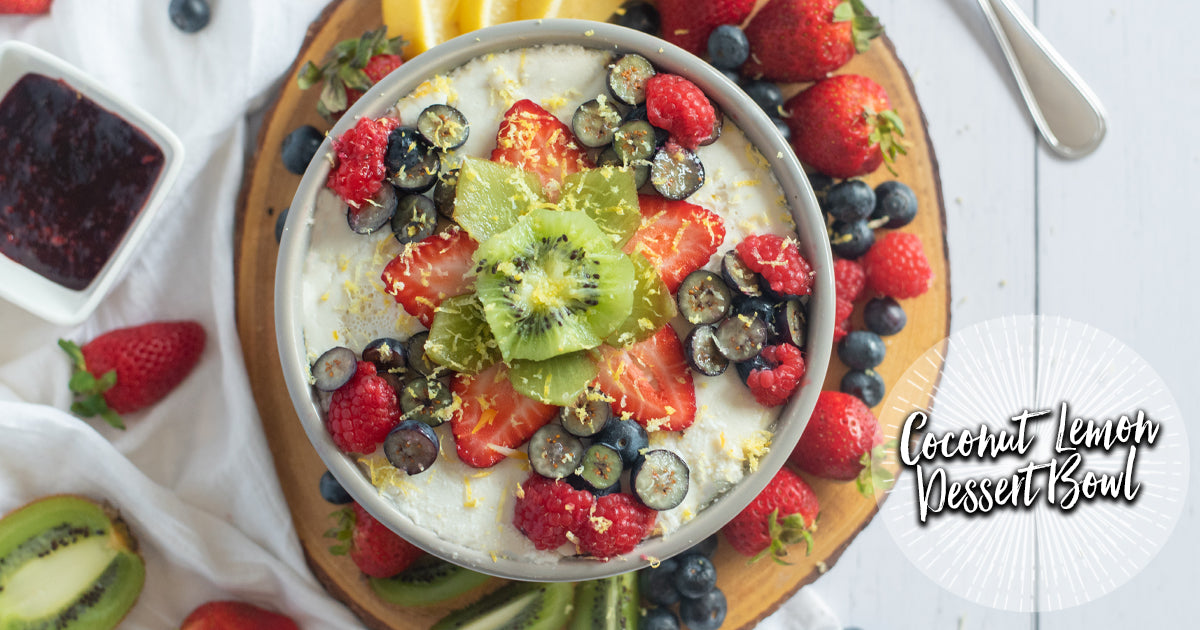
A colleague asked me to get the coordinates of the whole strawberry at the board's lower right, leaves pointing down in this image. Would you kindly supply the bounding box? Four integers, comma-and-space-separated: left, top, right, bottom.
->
721, 468, 820, 564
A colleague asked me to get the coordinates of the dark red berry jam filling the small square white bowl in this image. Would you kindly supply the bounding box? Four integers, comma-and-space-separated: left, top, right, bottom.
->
0, 73, 163, 290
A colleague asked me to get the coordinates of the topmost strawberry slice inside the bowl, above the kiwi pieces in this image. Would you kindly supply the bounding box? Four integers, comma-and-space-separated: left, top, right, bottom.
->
492, 98, 593, 199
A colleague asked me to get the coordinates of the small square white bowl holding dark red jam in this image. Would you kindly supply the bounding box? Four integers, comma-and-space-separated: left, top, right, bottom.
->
0, 41, 184, 326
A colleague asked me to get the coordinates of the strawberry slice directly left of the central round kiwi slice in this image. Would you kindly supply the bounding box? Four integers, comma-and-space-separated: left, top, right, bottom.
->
383, 229, 479, 328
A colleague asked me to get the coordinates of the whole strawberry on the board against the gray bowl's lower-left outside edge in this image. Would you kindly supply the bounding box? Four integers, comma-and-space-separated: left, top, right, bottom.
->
325, 503, 425, 577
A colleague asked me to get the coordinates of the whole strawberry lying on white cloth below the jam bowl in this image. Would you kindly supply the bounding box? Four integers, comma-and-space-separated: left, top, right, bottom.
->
59, 322, 206, 428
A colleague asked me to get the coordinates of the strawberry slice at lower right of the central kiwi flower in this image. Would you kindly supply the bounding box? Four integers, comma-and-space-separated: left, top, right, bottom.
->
600, 324, 696, 431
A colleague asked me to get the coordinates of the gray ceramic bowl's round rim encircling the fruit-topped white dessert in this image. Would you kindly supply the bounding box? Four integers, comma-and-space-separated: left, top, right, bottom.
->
275, 19, 834, 581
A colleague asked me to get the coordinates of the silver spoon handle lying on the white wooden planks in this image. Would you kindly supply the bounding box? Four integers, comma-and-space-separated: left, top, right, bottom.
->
979, 0, 1105, 158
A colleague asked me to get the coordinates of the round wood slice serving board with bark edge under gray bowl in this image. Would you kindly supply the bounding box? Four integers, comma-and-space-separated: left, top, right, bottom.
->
235, 0, 949, 630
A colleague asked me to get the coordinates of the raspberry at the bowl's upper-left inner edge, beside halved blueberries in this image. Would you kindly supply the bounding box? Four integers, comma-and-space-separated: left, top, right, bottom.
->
325, 118, 396, 208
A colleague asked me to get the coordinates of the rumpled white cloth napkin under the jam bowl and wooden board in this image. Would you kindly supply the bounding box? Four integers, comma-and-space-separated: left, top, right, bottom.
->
0, 0, 840, 630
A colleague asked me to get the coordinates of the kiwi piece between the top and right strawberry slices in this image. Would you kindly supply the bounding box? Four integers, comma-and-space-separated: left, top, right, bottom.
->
559, 166, 642, 248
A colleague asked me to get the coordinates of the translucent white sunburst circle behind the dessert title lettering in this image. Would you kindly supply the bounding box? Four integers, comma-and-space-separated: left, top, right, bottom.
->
880, 316, 1188, 612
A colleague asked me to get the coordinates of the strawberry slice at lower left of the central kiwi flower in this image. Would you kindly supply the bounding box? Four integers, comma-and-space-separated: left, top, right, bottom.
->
450, 364, 558, 468
